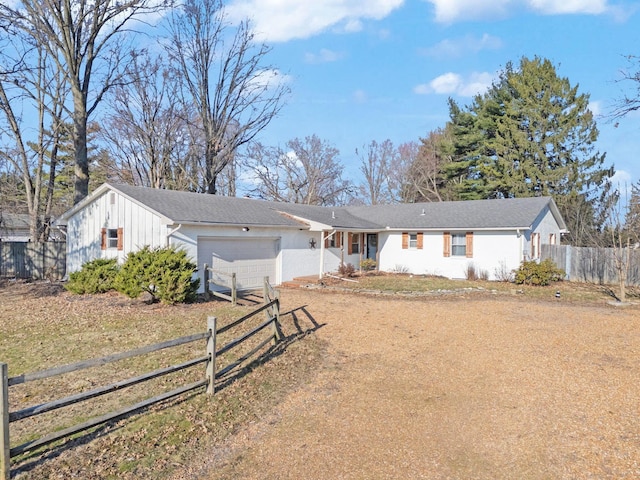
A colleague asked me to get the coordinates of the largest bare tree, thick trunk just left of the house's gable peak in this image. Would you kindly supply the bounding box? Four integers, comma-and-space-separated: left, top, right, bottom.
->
0, 0, 169, 203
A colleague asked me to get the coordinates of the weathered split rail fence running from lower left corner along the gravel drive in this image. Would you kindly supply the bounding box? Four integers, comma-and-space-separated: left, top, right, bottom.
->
0, 282, 280, 480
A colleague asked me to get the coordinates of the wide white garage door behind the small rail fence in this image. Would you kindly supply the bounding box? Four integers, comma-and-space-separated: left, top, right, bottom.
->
198, 238, 278, 290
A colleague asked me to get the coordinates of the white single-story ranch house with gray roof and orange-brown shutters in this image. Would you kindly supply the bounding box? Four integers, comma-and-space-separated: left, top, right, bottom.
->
59, 183, 566, 288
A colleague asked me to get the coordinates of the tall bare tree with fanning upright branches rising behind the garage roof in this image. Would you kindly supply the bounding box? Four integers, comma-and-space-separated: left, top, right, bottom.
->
168, 0, 289, 194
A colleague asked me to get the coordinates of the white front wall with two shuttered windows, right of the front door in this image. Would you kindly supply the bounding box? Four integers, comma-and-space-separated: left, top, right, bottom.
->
379, 231, 521, 278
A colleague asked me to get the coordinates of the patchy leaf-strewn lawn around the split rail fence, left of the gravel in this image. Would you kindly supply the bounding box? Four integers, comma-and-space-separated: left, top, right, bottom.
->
0, 283, 323, 479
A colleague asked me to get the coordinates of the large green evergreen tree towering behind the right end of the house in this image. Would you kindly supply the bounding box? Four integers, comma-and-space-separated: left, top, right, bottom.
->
444, 57, 613, 244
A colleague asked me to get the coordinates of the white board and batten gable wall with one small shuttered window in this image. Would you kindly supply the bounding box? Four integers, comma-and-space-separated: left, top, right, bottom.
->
67, 191, 167, 273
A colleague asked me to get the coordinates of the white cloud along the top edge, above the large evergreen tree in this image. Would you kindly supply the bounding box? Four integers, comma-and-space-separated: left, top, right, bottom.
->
426, 0, 616, 23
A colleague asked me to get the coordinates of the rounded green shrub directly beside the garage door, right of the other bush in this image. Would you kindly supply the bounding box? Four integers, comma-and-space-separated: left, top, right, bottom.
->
115, 246, 200, 304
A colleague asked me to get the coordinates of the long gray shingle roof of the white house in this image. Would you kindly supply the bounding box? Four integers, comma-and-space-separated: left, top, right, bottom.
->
64, 185, 566, 231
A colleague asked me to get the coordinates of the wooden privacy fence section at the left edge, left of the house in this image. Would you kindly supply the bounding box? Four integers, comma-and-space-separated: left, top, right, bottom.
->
0, 241, 67, 280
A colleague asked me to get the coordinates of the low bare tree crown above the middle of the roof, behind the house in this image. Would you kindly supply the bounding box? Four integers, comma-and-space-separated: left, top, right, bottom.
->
247, 135, 353, 205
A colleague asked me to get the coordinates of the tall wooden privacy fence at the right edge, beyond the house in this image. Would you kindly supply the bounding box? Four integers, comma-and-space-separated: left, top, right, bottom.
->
541, 245, 640, 286
